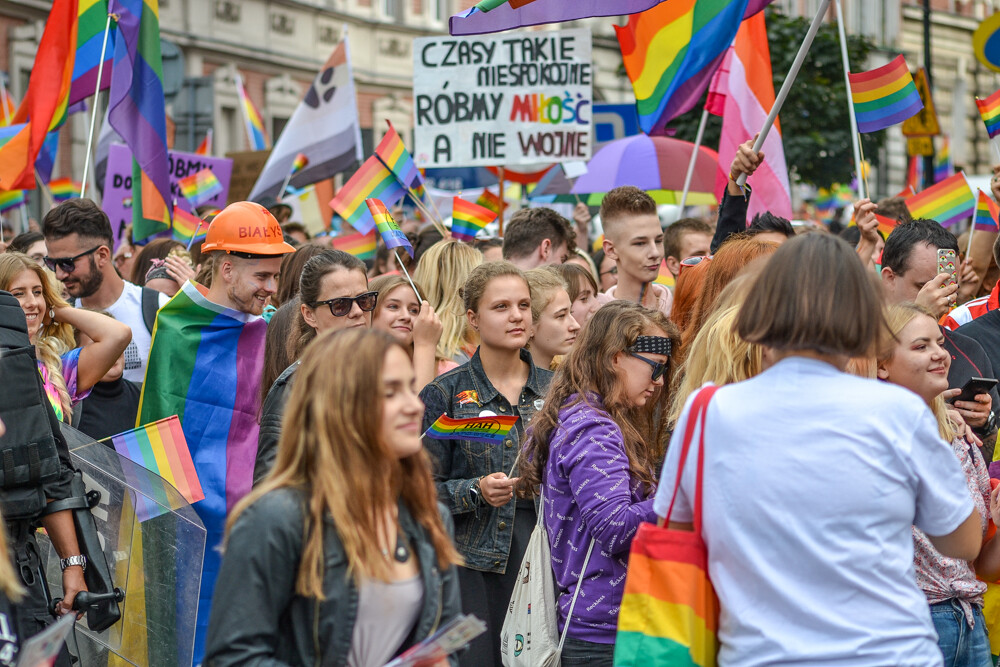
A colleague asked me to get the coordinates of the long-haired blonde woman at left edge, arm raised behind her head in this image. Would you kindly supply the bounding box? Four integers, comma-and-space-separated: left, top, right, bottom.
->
0, 252, 132, 422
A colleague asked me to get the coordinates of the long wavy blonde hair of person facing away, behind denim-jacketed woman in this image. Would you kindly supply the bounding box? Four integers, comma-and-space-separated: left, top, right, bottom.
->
413, 239, 483, 372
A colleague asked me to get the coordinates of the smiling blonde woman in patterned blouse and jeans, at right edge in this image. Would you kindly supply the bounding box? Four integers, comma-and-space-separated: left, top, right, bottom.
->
877, 303, 1000, 667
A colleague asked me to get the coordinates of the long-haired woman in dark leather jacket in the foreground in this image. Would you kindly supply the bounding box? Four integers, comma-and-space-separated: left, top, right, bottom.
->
205, 329, 461, 667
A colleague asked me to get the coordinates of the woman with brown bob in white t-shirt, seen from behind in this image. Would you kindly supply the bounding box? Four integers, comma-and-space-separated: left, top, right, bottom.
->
655, 234, 982, 667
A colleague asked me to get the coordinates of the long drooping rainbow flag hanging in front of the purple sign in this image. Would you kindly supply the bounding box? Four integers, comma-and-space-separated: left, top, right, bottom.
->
108, 0, 173, 241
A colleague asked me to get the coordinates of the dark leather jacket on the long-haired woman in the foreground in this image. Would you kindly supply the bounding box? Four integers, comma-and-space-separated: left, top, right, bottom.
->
204, 488, 461, 667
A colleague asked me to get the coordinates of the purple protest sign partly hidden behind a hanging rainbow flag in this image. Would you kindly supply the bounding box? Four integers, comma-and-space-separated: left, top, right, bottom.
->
101, 144, 233, 236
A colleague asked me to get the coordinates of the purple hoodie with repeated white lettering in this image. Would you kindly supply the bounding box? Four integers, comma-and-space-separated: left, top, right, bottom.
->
543, 394, 656, 644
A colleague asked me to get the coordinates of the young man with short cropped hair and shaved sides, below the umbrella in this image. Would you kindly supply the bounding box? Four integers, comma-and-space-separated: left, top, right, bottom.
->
597, 185, 674, 317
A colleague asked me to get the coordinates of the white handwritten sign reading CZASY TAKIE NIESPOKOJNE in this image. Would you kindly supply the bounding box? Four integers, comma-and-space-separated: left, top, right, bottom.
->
413, 29, 593, 167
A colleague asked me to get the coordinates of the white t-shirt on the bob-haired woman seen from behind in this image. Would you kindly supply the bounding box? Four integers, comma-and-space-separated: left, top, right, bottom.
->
654, 357, 973, 667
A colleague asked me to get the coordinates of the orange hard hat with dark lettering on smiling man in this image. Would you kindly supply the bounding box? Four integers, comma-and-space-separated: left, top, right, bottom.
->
201, 201, 295, 256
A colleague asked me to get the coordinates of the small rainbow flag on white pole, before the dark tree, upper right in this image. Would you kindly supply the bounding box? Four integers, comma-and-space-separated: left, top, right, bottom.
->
848, 55, 924, 132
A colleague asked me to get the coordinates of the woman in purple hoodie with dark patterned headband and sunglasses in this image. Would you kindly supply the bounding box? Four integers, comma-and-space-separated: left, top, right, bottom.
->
521, 302, 678, 667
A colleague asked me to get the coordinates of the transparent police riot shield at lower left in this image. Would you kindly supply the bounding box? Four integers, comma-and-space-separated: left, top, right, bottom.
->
38, 425, 206, 667
